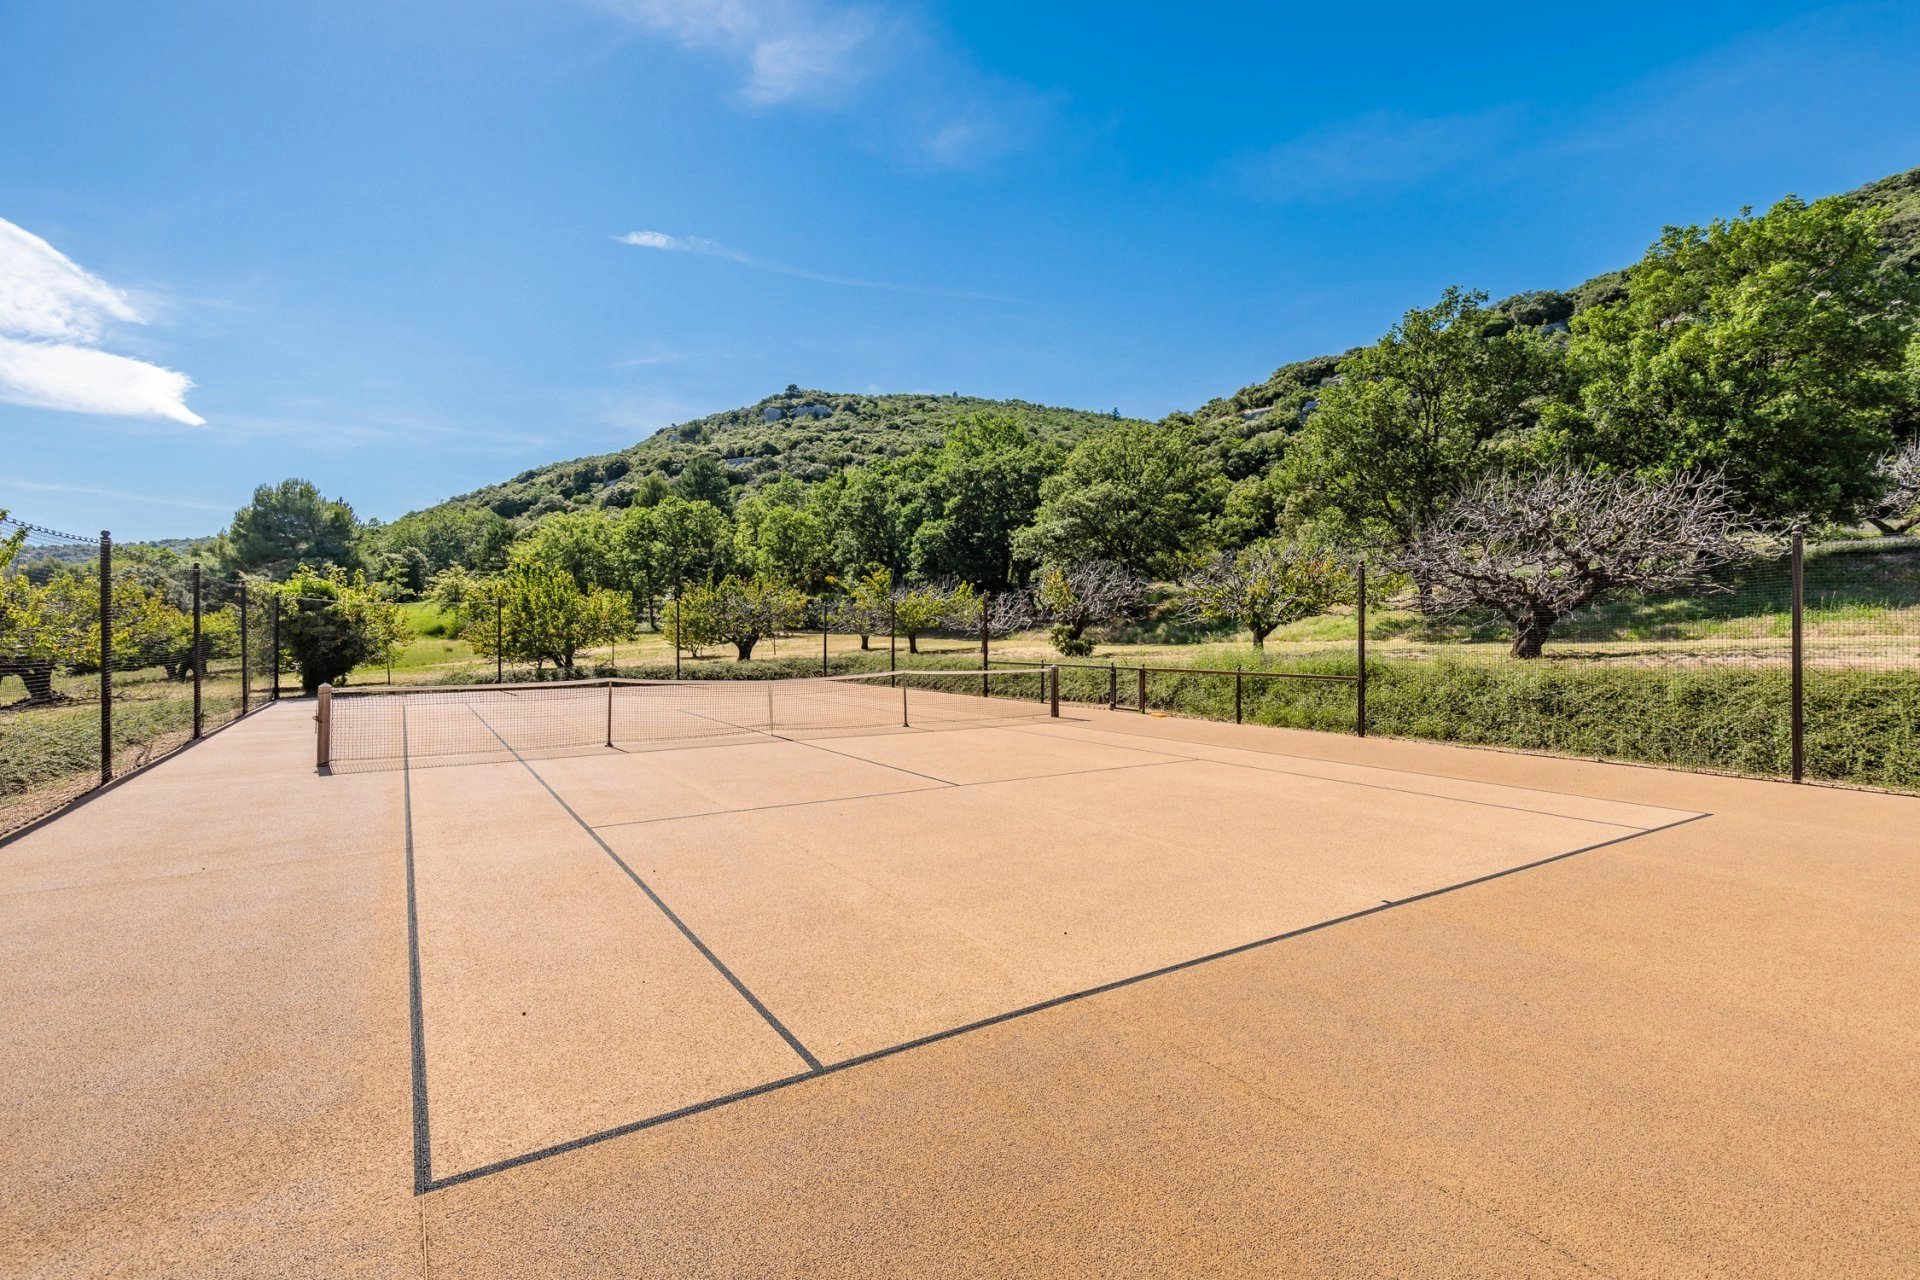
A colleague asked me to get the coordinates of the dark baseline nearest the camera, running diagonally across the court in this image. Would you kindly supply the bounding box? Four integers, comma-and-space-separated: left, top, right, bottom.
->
426, 812, 1713, 1192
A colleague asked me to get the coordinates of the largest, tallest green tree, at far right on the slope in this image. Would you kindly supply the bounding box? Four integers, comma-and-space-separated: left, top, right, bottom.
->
1559, 198, 1912, 520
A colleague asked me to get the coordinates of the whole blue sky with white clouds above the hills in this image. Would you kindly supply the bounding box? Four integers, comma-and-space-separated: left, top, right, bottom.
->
0, 0, 1920, 539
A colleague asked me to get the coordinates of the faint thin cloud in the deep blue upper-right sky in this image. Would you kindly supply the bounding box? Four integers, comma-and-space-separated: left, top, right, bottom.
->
1235, 109, 1515, 201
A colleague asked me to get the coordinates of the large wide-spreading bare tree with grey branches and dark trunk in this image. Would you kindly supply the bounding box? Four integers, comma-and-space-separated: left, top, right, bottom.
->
1396, 468, 1755, 658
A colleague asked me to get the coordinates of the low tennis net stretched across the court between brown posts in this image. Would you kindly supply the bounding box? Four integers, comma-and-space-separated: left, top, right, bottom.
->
317, 668, 1058, 770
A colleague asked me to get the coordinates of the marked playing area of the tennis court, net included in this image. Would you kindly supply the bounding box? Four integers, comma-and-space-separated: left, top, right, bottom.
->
311, 670, 1699, 1190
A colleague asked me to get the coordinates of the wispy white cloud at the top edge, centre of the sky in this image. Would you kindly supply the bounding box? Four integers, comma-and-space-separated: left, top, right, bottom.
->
597, 0, 1054, 169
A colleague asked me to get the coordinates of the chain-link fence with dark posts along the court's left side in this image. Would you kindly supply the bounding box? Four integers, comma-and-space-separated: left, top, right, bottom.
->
0, 518, 278, 835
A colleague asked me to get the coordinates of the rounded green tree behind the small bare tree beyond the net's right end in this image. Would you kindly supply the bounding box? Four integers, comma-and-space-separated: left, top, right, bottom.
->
1012, 422, 1223, 574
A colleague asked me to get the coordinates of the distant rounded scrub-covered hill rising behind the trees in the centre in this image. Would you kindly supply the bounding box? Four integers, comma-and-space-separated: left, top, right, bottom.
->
428, 386, 1123, 518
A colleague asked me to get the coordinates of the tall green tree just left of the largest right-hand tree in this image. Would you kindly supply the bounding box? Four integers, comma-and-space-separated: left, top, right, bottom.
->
1283, 288, 1563, 556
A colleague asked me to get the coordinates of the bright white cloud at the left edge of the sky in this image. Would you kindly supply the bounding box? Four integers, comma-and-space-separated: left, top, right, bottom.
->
0, 219, 205, 426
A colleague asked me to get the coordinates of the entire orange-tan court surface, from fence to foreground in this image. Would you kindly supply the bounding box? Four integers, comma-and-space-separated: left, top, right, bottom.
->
0, 672, 1920, 1276
